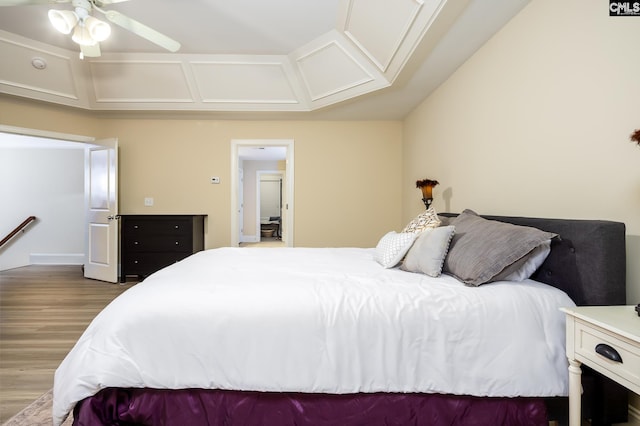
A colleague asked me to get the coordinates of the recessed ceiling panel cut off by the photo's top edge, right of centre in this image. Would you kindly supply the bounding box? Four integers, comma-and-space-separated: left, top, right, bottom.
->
344, 0, 423, 72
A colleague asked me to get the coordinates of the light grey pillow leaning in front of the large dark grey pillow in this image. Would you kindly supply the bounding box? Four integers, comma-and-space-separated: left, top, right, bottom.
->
400, 226, 455, 277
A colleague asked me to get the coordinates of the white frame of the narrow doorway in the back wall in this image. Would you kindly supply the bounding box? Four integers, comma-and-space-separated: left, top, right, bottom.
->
230, 139, 294, 247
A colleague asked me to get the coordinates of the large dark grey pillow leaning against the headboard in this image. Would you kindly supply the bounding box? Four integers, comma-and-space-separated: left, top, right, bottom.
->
443, 210, 557, 286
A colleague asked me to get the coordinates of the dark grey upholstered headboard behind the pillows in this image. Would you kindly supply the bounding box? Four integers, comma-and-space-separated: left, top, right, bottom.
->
442, 213, 626, 305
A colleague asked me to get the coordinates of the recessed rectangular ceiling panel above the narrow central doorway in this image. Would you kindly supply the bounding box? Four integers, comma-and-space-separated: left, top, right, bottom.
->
191, 60, 299, 104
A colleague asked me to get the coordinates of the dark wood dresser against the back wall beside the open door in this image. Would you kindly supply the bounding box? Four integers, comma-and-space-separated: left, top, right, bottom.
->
120, 215, 206, 282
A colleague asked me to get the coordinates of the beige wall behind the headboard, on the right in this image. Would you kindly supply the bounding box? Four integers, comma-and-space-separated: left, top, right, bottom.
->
402, 0, 640, 304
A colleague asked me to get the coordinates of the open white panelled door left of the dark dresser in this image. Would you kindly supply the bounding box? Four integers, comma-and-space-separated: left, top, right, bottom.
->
84, 139, 118, 283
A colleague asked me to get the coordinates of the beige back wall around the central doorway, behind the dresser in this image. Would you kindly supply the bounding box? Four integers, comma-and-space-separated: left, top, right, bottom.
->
0, 96, 402, 248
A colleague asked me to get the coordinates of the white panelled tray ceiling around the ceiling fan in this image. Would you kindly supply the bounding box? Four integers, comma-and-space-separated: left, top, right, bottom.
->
0, 0, 528, 119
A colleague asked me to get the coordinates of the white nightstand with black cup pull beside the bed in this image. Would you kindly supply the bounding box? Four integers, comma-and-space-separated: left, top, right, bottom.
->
562, 306, 640, 426
